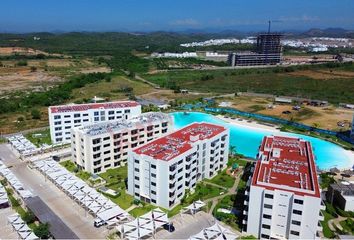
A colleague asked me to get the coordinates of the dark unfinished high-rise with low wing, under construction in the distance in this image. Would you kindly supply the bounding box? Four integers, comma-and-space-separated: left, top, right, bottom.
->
228, 33, 282, 66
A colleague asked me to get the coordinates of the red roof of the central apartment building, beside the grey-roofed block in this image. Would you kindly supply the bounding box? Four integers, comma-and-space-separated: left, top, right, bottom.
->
133, 123, 226, 161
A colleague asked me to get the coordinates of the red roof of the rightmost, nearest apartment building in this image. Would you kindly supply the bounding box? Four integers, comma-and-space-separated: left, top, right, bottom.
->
252, 136, 320, 197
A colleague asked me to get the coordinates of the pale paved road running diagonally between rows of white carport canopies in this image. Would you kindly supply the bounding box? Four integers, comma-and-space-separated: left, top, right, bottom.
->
0, 144, 107, 239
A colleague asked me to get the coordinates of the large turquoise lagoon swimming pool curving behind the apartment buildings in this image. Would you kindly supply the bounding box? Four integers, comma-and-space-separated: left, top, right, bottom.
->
171, 112, 354, 170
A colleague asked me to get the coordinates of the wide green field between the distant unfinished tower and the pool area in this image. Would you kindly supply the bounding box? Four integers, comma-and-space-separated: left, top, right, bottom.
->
144, 63, 354, 103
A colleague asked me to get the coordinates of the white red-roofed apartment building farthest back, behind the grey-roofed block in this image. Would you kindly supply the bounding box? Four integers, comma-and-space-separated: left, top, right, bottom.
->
48, 101, 141, 143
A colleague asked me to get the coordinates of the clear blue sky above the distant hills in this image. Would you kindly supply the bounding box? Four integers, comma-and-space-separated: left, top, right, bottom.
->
0, 0, 354, 32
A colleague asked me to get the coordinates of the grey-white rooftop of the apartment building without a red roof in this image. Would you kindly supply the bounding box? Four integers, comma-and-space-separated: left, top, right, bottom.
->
77, 112, 171, 136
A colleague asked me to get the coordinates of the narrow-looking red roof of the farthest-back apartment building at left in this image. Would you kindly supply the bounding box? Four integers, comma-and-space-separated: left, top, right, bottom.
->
49, 101, 140, 113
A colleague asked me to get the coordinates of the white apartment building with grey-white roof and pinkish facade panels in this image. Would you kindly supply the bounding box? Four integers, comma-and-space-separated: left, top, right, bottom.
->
71, 112, 173, 173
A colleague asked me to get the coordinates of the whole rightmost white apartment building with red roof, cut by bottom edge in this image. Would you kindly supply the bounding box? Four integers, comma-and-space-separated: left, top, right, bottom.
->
243, 136, 325, 239
